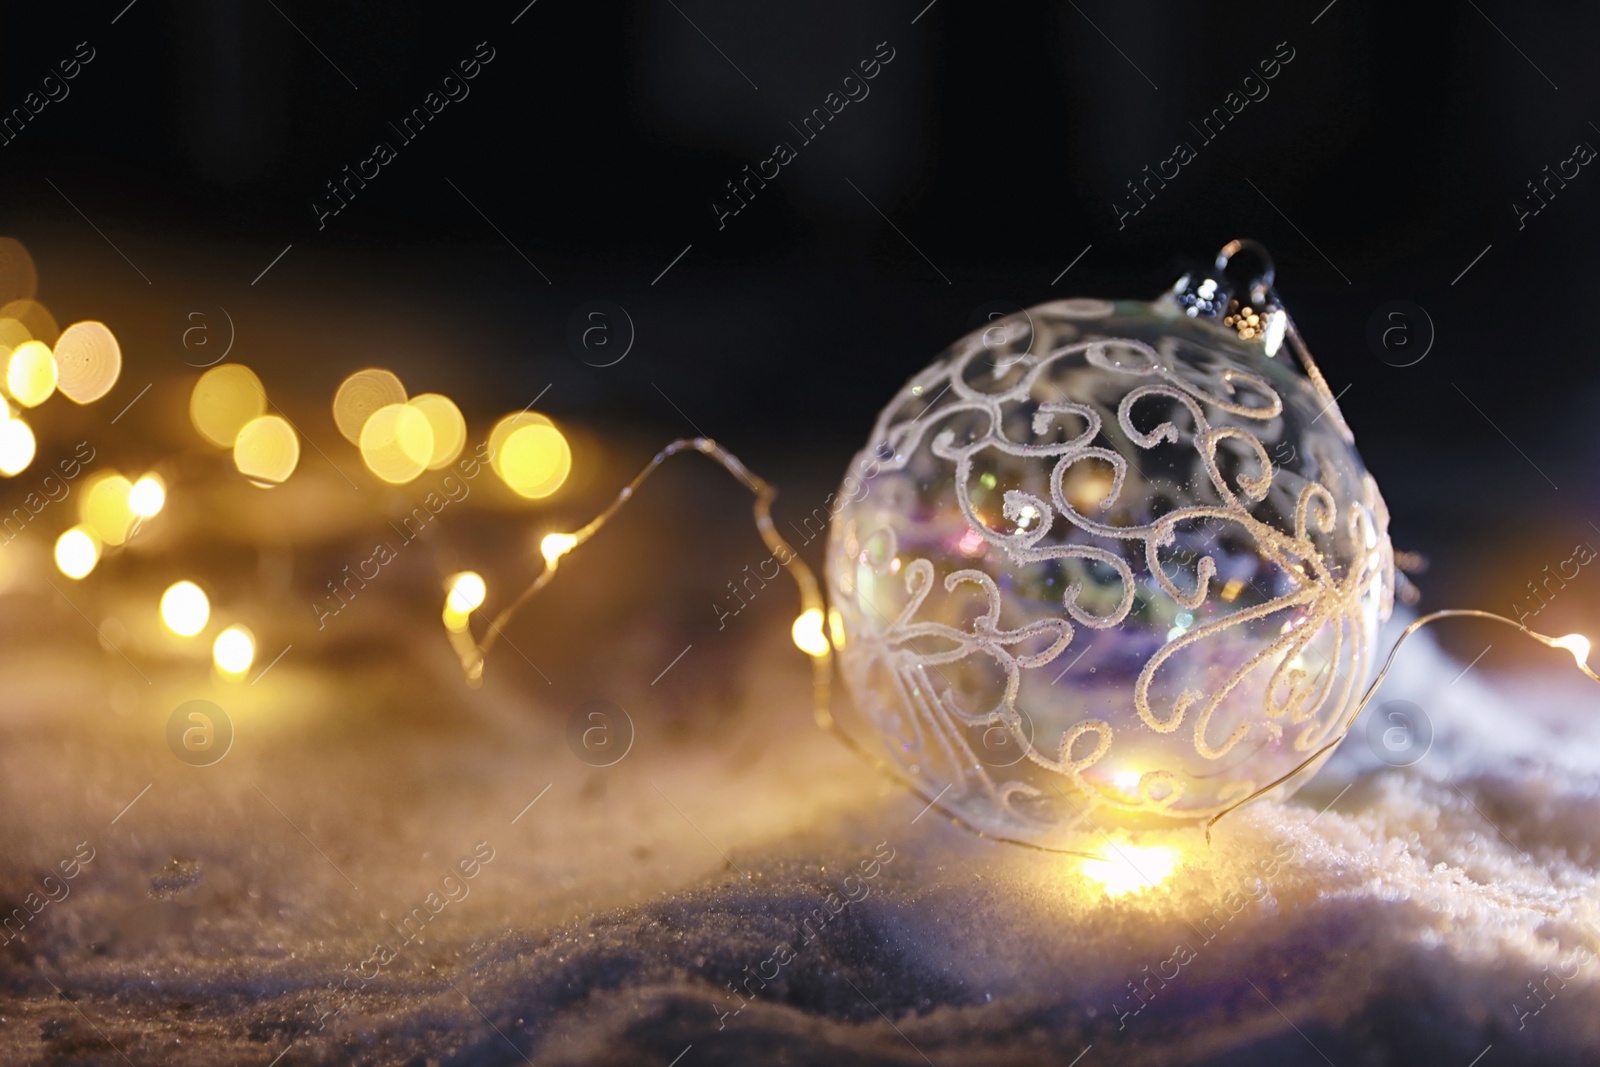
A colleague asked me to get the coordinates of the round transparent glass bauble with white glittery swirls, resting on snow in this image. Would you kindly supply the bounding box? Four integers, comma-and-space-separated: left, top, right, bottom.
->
827, 294, 1394, 848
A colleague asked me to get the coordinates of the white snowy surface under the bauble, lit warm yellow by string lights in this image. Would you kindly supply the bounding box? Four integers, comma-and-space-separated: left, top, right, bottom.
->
0, 489, 1600, 1067
